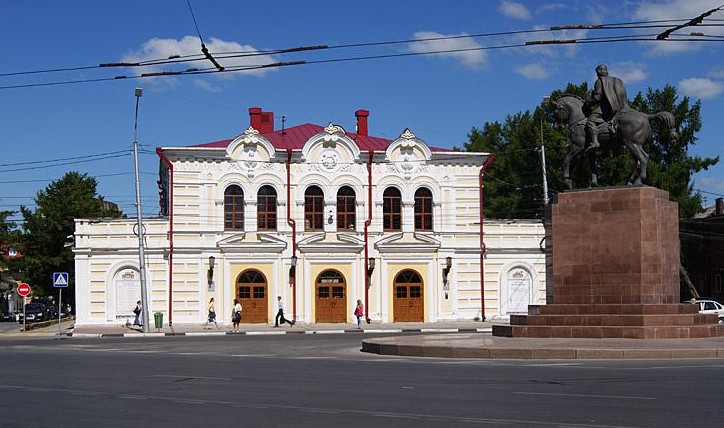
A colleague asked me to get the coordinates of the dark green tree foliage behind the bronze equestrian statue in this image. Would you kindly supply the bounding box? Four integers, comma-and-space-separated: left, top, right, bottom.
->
464, 82, 719, 218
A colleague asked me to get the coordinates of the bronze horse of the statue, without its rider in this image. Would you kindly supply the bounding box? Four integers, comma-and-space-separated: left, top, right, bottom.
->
553, 95, 678, 189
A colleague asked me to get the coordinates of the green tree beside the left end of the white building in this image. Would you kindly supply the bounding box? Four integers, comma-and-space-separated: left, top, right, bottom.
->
19, 172, 121, 299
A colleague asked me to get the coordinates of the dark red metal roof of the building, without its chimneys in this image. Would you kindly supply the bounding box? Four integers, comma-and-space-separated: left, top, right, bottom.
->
192, 123, 449, 152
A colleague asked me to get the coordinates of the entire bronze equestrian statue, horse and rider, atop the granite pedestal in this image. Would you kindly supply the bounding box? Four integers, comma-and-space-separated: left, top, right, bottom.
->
553, 64, 678, 189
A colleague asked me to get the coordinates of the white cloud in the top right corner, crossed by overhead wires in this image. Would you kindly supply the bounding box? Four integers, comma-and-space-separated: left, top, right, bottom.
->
633, 0, 724, 54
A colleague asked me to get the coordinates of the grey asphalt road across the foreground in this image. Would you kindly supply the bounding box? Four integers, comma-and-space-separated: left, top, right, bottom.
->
0, 335, 724, 428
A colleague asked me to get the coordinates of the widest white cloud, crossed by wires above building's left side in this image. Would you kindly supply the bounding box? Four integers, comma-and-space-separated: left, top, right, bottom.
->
122, 36, 276, 90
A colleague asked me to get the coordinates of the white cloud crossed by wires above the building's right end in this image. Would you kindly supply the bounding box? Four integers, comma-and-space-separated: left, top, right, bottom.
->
410, 31, 488, 68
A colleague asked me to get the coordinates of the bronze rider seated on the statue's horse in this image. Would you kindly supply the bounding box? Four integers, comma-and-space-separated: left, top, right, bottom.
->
586, 64, 629, 149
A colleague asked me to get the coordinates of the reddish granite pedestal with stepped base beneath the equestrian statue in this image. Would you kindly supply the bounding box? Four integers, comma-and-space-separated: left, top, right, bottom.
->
493, 186, 724, 339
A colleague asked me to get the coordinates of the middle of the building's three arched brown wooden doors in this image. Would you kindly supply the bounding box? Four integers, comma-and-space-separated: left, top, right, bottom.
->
314, 269, 347, 323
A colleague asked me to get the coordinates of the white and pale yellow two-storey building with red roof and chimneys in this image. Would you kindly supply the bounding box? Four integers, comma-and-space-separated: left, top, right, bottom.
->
74, 108, 545, 325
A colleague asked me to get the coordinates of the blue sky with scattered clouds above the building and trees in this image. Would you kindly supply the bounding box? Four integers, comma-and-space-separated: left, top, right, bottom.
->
0, 0, 724, 224
